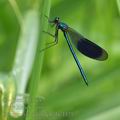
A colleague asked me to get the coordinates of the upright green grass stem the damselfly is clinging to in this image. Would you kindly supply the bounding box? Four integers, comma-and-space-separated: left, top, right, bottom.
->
26, 0, 50, 120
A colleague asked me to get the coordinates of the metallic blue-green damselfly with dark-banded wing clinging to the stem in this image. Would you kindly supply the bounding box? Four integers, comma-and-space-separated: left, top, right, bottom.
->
43, 17, 108, 85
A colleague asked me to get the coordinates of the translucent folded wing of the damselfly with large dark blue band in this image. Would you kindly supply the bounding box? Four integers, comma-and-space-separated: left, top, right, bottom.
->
68, 28, 108, 61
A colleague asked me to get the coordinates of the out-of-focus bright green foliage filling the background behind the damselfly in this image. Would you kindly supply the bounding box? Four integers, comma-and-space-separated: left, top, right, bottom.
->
0, 0, 120, 120
